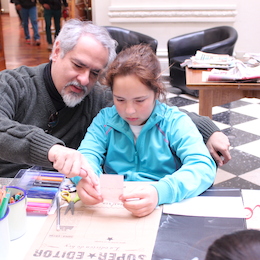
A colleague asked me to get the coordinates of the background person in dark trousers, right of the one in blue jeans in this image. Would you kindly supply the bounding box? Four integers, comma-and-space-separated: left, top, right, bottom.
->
39, 0, 68, 50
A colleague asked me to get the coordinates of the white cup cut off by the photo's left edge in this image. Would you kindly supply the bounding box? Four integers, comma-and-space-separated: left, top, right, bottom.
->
0, 207, 10, 260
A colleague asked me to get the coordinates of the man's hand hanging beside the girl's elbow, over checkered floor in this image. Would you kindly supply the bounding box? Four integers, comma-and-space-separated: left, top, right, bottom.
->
206, 132, 231, 166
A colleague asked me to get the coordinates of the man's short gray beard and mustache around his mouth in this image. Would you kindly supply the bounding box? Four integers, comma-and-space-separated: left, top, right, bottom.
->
61, 81, 88, 107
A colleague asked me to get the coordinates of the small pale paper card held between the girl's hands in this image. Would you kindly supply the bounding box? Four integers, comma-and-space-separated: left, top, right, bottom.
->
100, 174, 124, 203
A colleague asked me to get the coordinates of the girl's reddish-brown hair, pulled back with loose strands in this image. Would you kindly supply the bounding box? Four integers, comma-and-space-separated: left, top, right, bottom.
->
105, 44, 166, 101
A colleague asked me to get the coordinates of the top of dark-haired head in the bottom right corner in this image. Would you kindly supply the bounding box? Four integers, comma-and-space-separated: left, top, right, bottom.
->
205, 229, 260, 260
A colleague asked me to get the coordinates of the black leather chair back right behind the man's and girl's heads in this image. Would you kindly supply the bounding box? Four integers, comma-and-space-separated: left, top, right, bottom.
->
105, 26, 158, 53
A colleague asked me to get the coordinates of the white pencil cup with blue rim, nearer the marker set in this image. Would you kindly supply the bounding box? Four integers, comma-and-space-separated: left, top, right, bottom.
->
6, 186, 27, 240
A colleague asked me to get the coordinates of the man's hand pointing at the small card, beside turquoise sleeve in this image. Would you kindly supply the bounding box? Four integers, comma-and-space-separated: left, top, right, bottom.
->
48, 144, 99, 186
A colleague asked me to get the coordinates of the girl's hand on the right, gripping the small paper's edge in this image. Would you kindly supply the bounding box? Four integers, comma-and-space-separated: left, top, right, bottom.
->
120, 185, 158, 217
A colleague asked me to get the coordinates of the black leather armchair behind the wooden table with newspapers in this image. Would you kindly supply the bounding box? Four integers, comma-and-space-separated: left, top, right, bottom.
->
167, 26, 238, 97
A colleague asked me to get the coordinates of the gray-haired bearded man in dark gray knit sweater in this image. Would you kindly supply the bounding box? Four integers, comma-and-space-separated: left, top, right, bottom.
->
0, 19, 230, 179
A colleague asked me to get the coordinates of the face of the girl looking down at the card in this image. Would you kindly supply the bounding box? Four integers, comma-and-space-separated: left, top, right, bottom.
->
113, 75, 156, 125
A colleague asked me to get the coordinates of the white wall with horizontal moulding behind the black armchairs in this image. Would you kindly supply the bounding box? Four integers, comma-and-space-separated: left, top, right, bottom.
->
92, 0, 260, 74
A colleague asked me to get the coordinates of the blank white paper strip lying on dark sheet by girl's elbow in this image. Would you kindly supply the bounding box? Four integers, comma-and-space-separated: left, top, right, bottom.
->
163, 196, 246, 218
